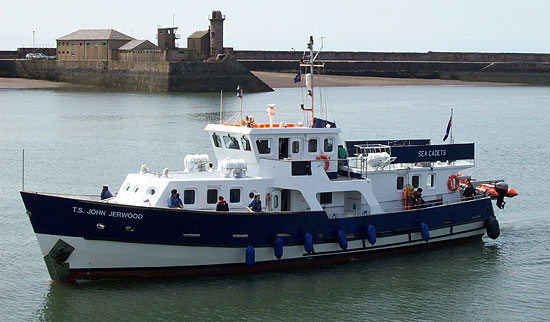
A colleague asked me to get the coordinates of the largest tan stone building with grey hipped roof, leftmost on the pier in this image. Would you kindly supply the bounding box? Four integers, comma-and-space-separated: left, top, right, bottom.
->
56, 29, 134, 60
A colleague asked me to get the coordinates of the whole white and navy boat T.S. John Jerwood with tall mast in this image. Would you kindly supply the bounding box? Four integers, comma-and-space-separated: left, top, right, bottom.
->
21, 38, 512, 281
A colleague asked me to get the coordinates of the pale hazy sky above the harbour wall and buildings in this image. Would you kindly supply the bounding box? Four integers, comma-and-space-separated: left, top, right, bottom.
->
0, 0, 550, 53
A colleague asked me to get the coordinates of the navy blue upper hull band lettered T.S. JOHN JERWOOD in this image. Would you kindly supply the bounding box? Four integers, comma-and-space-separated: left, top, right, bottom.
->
21, 191, 494, 247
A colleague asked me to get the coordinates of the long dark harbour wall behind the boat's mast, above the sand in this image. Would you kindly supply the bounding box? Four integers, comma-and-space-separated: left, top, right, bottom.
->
235, 51, 550, 85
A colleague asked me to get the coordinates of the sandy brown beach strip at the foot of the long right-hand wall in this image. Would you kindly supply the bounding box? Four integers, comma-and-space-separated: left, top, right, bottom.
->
252, 72, 514, 88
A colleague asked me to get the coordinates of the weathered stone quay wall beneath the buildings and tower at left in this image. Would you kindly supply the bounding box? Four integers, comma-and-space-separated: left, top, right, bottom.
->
0, 56, 272, 92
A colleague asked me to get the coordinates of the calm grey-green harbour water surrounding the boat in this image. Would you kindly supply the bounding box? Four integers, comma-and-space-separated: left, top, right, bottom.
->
0, 86, 550, 321
